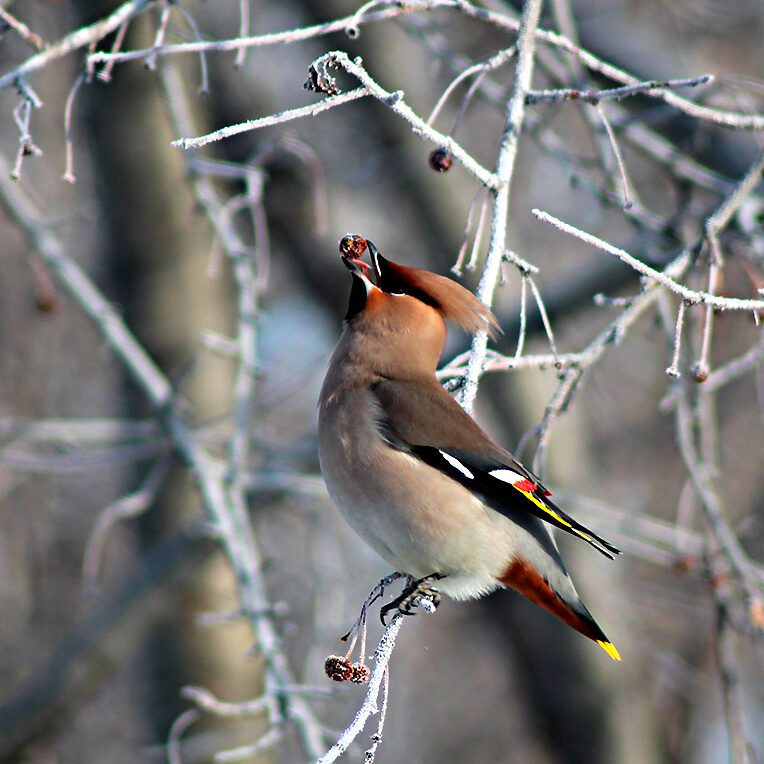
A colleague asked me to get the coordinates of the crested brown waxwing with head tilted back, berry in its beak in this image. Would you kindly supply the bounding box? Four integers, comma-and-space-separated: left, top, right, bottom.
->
318, 234, 621, 660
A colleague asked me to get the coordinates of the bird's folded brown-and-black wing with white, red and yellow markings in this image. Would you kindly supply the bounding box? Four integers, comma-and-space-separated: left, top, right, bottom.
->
371, 378, 620, 559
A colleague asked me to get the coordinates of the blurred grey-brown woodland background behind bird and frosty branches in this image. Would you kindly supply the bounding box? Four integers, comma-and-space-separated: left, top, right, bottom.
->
0, 0, 764, 764
